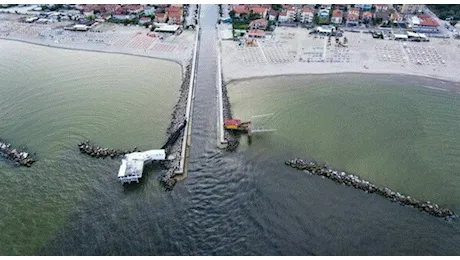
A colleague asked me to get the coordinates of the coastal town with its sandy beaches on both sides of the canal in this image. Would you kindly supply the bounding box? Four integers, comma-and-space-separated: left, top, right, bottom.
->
0, 4, 460, 84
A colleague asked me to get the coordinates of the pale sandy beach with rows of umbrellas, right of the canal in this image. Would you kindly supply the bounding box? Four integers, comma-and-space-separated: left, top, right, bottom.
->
220, 25, 460, 87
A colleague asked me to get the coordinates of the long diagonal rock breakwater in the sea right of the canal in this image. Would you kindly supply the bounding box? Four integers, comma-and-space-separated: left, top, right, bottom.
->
285, 159, 457, 219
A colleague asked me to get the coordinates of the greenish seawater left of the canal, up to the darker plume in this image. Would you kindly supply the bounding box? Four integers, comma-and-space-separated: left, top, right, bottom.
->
0, 41, 181, 255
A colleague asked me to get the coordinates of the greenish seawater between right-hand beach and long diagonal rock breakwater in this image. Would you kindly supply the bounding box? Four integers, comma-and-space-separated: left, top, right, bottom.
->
228, 74, 460, 206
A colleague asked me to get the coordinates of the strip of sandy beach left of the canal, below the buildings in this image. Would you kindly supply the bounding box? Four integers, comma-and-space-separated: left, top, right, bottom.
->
0, 14, 195, 72
